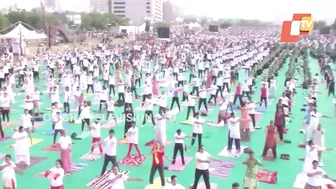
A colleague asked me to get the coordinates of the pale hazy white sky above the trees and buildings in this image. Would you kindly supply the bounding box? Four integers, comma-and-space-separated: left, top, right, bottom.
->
0, 0, 336, 21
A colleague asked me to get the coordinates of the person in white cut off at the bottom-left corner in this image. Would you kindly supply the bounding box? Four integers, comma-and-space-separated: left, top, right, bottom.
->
0, 154, 22, 189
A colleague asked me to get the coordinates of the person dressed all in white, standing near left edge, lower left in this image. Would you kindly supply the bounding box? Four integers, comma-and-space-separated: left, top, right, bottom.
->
12, 126, 30, 167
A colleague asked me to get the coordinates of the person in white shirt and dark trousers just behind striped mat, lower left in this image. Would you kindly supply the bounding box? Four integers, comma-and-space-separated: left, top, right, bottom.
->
100, 129, 118, 176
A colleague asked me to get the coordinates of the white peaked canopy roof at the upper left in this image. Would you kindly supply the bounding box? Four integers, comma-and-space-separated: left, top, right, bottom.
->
0, 22, 47, 40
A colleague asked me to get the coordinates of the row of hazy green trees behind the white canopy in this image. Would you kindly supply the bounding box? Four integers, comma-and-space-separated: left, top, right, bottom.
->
0, 8, 130, 30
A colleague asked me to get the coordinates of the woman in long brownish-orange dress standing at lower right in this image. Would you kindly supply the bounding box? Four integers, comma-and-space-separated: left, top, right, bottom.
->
262, 121, 277, 158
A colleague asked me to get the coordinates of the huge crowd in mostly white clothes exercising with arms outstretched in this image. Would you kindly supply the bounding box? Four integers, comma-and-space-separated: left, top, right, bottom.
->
0, 25, 334, 189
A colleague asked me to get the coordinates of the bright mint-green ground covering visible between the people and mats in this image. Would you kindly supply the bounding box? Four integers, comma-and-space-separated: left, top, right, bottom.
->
0, 55, 336, 189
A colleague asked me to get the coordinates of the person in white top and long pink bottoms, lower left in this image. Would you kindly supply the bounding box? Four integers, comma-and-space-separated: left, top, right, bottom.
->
58, 130, 72, 173
